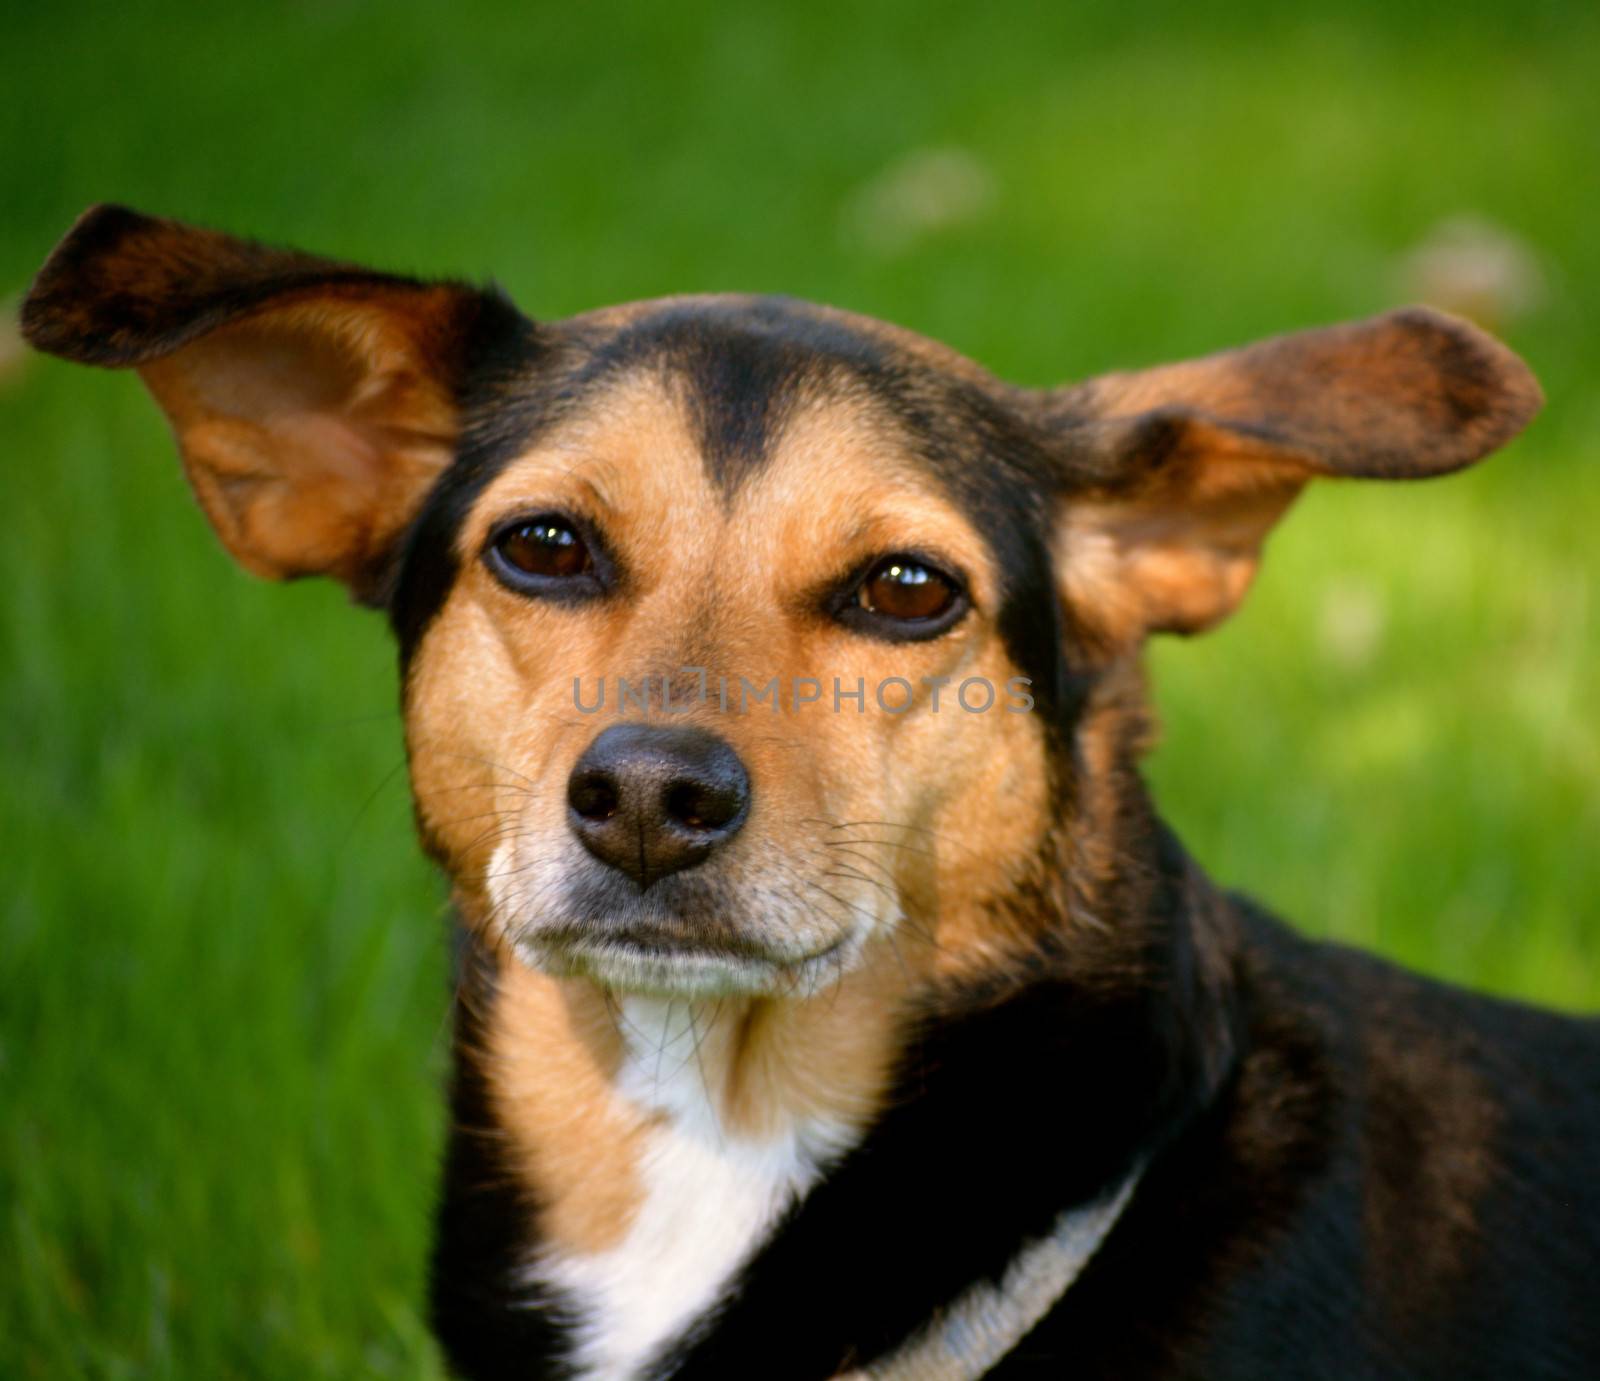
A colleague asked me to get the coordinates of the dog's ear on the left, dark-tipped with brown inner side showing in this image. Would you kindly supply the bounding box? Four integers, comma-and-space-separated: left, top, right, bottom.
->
22, 206, 534, 602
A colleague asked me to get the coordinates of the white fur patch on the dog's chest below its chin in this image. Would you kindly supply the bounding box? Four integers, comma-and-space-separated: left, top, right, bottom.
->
530, 999, 850, 1381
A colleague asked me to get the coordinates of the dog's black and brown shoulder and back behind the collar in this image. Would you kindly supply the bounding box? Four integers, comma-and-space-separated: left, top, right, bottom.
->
1062, 904, 1600, 1378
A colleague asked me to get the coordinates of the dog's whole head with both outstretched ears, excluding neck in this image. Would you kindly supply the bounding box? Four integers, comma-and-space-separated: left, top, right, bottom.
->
24, 208, 1539, 994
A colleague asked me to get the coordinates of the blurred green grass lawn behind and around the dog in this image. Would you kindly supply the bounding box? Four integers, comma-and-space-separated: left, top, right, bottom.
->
0, 0, 1600, 1378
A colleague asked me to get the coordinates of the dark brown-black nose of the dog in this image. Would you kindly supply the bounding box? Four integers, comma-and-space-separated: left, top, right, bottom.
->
566, 725, 750, 887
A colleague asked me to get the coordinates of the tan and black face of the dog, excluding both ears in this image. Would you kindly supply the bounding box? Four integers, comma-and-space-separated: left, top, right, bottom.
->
400, 301, 1054, 992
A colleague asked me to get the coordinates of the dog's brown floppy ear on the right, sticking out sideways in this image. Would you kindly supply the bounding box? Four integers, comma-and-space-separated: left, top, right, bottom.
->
1035, 307, 1542, 650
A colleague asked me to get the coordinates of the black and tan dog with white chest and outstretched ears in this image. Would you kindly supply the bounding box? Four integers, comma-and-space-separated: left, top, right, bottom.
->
22, 206, 1600, 1381
